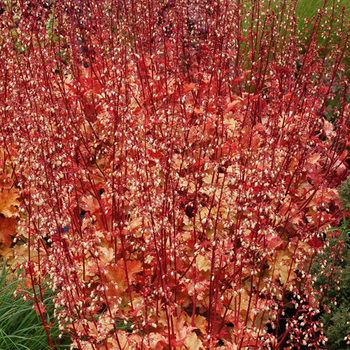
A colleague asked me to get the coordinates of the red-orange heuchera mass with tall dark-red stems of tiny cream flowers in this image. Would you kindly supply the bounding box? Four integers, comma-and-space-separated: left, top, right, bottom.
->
0, 0, 350, 350
